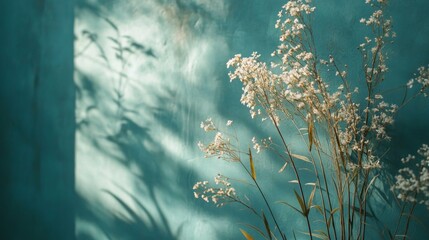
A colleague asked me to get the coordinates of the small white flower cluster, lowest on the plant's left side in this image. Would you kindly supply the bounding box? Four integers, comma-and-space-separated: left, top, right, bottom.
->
192, 174, 238, 207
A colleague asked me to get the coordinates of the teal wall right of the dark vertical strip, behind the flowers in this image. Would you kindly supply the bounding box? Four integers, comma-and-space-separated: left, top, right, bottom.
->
75, 0, 429, 239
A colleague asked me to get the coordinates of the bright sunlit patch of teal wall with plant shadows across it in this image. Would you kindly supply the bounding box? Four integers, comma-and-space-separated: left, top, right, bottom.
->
75, 0, 251, 239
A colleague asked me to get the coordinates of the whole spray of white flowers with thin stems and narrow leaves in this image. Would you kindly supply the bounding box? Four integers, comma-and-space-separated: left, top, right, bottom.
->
194, 0, 429, 238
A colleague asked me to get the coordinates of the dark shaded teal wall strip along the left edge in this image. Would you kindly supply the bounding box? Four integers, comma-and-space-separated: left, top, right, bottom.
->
0, 0, 75, 239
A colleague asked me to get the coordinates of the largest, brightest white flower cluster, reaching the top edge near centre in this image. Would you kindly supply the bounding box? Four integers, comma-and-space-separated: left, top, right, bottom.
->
227, 0, 319, 124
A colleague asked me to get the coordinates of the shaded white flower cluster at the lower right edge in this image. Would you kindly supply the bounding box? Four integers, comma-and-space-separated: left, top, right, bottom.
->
392, 144, 429, 209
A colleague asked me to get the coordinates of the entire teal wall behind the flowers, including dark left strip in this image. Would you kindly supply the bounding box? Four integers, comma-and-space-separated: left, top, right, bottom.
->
0, 0, 429, 239
